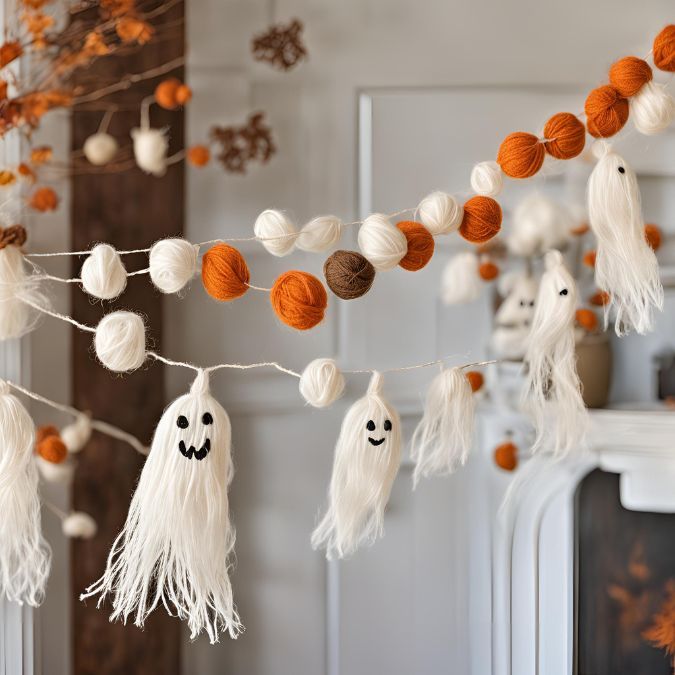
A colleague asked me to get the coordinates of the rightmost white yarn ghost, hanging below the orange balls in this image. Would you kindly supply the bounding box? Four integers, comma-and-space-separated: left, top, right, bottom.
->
588, 142, 663, 335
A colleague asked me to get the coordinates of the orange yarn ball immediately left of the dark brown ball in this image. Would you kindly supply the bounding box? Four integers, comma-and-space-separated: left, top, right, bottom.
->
270, 270, 328, 330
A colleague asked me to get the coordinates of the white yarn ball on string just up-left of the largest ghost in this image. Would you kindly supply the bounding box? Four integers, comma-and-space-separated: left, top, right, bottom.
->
94, 311, 145, 373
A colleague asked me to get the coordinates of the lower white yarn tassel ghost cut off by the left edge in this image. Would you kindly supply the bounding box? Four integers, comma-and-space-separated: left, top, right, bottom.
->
0, 381, 51, 607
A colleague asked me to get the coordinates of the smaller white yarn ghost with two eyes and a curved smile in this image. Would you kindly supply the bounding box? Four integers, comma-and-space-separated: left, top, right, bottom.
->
312, 372, 401, 559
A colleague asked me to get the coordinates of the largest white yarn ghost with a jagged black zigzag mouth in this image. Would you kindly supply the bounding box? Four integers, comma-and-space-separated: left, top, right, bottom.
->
81, 371, 241, 644
